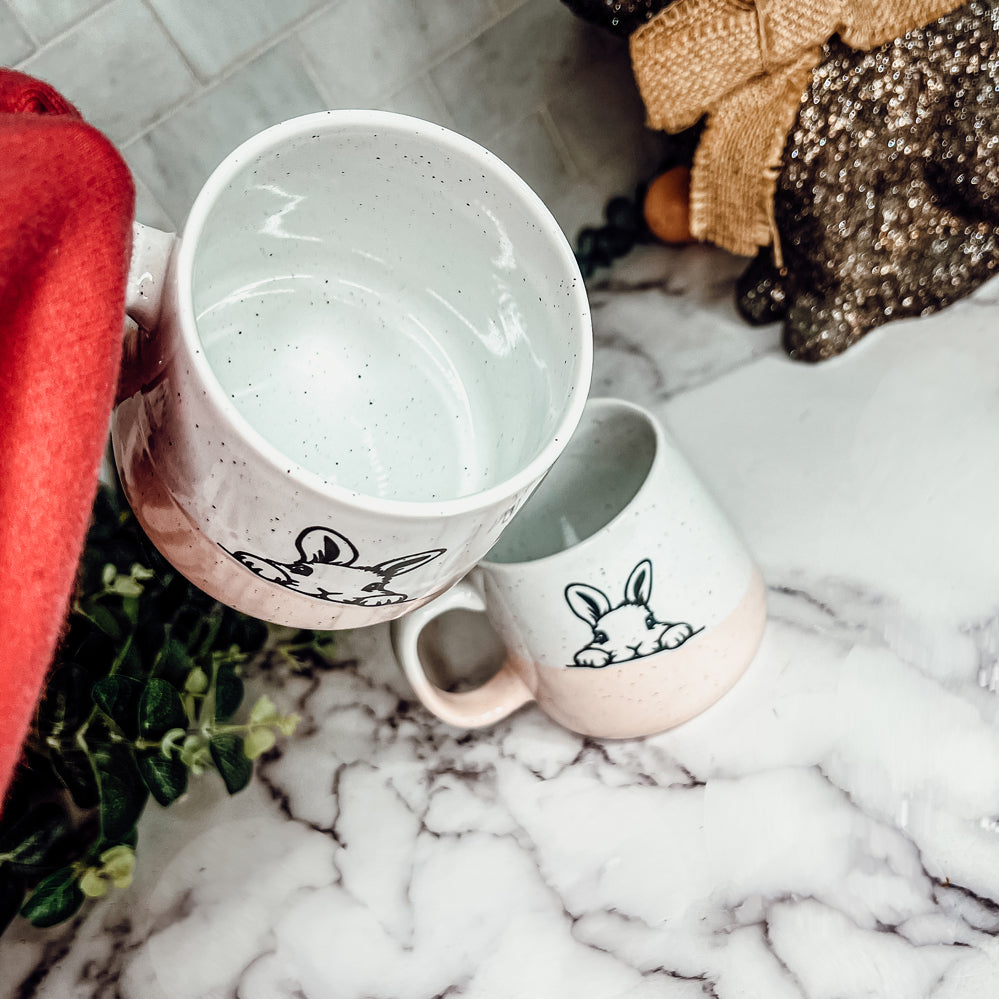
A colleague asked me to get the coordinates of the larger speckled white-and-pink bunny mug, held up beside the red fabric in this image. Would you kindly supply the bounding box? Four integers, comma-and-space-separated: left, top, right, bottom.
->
112, 111, 592, 629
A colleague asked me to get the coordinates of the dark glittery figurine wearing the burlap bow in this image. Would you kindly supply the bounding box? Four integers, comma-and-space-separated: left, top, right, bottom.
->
737, 0, 999, 361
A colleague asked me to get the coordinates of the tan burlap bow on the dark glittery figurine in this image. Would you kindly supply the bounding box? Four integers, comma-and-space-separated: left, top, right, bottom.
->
631, 0, 966, 264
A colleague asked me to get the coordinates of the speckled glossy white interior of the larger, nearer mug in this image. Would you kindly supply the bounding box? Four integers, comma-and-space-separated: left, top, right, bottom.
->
181, 112, 589, 501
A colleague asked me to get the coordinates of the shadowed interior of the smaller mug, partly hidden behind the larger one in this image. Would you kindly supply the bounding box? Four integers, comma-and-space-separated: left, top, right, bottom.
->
486, 400, 658, 563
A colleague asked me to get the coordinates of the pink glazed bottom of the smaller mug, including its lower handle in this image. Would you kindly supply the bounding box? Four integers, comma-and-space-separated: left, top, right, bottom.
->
400, 571, 766, 739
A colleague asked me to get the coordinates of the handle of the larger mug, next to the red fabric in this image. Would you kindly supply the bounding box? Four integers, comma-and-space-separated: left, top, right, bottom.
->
115, 222, 177, 405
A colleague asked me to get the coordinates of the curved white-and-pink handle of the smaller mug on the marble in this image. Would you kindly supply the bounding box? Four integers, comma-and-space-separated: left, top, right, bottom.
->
390, 579, 534, 728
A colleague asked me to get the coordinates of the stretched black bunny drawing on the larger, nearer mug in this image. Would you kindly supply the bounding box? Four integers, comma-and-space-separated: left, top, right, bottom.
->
229, 527, 445, 607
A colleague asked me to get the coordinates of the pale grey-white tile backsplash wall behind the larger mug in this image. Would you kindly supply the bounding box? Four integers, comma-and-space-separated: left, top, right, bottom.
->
9, 0, 660, 258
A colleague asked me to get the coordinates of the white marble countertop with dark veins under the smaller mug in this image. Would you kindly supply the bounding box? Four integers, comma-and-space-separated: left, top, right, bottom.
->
0, 247, 999, 999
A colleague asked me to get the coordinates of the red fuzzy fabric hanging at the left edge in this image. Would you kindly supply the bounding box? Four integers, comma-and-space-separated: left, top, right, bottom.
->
0, 69, 135, 801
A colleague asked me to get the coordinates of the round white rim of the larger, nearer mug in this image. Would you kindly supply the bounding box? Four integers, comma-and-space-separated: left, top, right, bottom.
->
174, 109, 593, 519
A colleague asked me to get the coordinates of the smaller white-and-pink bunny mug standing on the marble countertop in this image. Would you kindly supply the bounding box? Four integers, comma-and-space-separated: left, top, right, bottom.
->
392, 399, 766, 738
